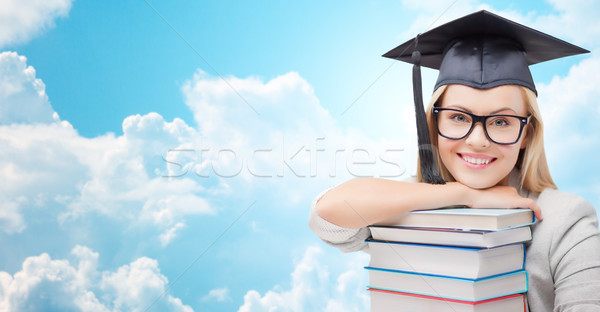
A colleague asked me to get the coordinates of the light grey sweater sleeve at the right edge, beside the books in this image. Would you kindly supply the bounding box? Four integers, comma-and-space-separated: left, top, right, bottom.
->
549, 196, 600, 312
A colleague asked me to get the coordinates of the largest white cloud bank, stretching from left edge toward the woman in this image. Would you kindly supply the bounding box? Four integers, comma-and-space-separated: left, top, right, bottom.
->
0, 53, 412, 246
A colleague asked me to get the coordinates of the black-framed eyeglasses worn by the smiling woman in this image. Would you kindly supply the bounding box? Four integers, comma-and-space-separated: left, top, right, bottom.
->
433, 107, 531, 145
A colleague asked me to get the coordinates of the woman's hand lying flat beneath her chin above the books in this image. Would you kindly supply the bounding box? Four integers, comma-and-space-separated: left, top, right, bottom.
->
457, 182, 542, 221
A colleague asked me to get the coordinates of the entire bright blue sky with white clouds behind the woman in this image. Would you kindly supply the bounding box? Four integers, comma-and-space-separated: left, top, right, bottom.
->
0, 0, 600, 312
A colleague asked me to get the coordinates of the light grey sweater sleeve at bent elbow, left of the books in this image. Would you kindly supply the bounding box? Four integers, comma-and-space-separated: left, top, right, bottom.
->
308, 189, 371, 252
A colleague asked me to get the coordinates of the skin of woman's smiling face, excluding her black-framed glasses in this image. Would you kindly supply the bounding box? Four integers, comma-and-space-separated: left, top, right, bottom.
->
438, 85, 528, 188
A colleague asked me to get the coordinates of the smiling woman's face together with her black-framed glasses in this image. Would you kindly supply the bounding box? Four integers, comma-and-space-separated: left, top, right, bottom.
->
430, 85, 536, 191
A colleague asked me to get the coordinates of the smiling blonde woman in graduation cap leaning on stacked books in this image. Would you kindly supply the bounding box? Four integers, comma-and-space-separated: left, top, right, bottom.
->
309, 11, 600, 311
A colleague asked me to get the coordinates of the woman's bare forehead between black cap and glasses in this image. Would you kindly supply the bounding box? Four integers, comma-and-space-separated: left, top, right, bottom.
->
441, 85, 527, 115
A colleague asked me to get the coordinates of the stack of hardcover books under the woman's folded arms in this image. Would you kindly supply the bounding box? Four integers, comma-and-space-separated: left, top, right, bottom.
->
365, 208, 535, 312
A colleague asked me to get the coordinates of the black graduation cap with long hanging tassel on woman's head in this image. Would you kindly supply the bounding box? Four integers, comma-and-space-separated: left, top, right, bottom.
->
383, 11, 589, 184
